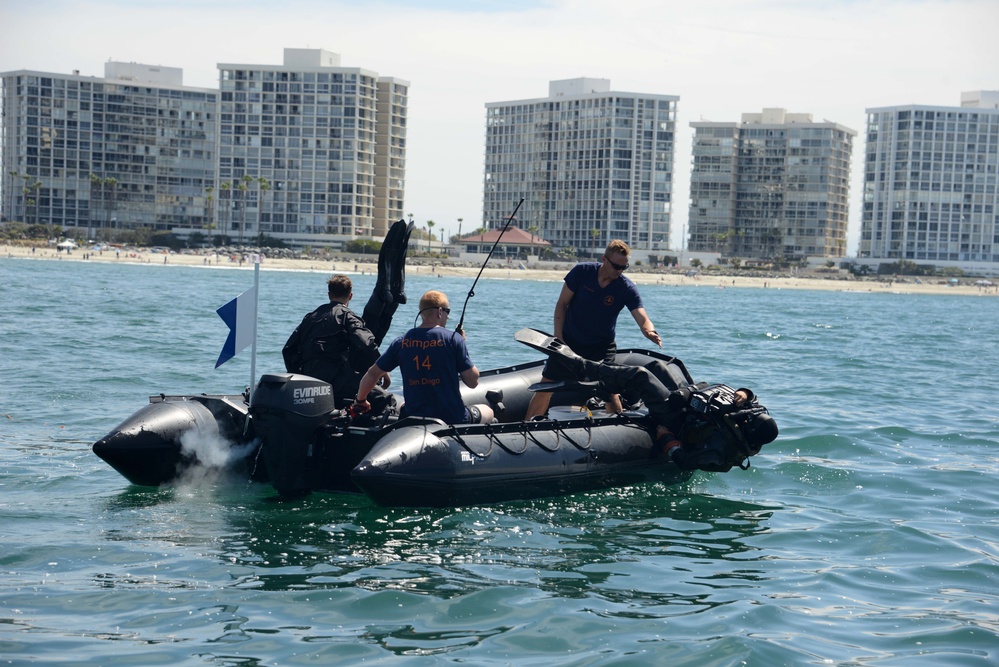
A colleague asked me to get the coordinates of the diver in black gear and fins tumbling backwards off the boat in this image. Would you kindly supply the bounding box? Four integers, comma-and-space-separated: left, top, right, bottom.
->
522, 338, 778, 472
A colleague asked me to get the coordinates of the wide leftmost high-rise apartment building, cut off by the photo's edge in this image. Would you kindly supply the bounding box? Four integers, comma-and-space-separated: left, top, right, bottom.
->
0, 62, 218, 238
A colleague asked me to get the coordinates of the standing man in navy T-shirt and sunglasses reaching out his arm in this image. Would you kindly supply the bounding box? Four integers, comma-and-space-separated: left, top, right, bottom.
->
525, 239, 663, 421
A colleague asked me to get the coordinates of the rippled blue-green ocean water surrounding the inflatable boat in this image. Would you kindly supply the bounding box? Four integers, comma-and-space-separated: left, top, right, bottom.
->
0, 258, 999, 667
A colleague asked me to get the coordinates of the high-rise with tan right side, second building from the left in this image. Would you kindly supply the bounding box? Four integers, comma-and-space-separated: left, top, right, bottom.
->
216, 49, 409, 246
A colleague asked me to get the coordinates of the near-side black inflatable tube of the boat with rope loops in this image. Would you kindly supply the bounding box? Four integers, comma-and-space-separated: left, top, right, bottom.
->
351, 408, 692, 507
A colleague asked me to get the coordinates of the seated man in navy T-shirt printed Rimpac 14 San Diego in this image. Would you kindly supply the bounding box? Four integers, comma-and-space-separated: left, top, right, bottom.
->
351, 290, 493, 424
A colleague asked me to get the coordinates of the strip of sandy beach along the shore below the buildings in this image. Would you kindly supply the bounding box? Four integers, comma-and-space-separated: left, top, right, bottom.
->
0, 245, 999, 296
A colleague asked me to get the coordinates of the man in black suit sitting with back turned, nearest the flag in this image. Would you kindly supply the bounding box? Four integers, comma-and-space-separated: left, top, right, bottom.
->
281, 274, 388, 408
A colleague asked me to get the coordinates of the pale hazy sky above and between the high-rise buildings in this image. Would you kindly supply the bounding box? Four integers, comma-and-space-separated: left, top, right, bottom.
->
0, 0, 999, 254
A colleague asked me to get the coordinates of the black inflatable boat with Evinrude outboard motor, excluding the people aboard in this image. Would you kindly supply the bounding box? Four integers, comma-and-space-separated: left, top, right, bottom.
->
94, 350, 768, 507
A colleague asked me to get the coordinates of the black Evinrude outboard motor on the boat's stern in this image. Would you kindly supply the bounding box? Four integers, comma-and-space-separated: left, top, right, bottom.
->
250, 373, 336, 497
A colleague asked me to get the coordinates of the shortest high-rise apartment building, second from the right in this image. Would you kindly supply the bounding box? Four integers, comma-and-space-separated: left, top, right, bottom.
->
689, 109, 857, 260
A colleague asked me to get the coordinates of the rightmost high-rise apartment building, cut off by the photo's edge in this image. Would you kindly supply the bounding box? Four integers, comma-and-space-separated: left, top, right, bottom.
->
858, 91, 999, 264
